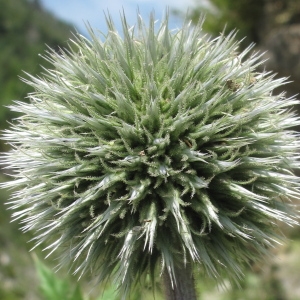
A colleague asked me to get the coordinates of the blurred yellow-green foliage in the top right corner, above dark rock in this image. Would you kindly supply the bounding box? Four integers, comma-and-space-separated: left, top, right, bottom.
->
184, 0, 300, 47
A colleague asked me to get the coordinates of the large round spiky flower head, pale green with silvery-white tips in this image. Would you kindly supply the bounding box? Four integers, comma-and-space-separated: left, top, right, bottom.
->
2, 11, 300, 294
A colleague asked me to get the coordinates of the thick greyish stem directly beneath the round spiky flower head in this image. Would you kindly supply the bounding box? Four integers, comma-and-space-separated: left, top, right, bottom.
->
163, 264, 197, 300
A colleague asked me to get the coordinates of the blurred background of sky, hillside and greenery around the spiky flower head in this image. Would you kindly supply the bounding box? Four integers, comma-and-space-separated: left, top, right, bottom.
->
0, 0, 300, 300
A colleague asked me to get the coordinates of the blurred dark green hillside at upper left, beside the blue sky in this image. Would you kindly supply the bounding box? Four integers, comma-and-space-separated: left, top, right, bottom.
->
0, 0, 74, 151
